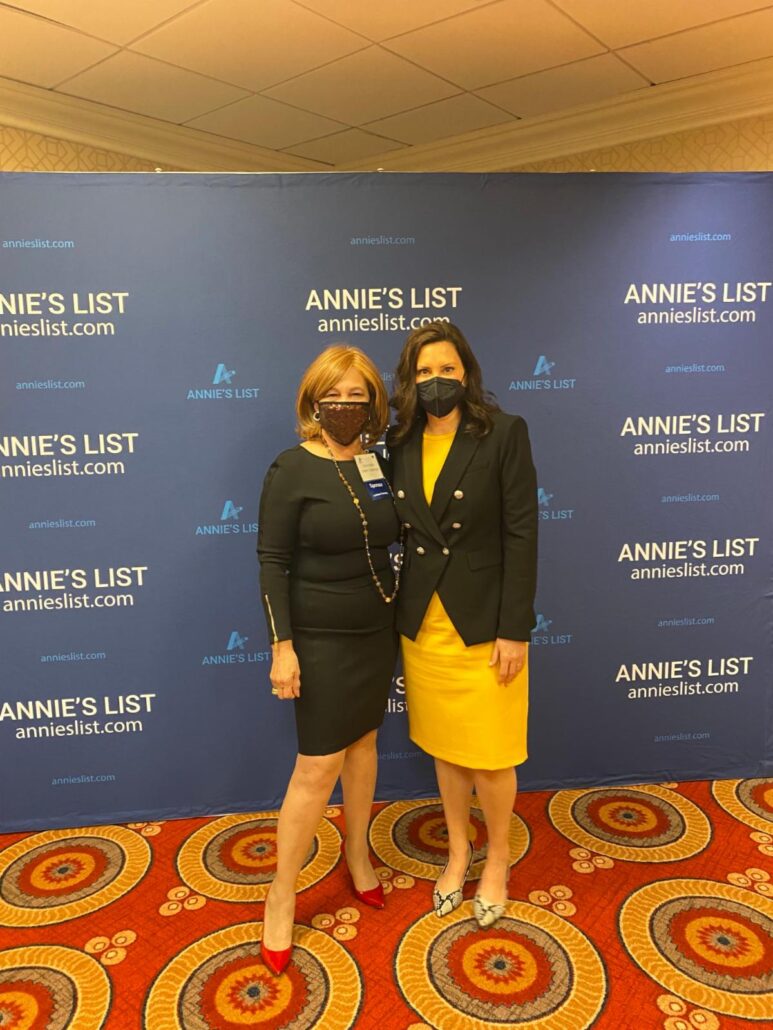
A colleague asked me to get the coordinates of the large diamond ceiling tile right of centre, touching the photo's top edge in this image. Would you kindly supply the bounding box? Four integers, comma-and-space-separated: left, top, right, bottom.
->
383, 0, 605, 89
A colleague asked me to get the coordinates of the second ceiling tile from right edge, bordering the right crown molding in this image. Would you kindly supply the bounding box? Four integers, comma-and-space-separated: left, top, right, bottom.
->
477, 54, 649, 118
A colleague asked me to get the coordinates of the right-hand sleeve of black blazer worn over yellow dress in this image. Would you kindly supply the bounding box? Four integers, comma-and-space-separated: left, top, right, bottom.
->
497, 416, 537, 641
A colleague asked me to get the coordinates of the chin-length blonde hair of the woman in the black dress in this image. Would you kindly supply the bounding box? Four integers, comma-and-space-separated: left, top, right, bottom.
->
295, 343, 390, 444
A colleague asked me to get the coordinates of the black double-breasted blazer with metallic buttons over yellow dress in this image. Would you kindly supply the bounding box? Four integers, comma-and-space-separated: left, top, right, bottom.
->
390, 412, 537, 647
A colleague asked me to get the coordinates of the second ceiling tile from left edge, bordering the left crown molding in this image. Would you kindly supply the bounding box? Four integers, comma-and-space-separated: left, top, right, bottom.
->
59, 50, 245, 123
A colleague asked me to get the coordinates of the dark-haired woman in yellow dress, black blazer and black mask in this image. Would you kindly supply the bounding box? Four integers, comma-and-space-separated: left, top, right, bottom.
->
390, 321, 537, 926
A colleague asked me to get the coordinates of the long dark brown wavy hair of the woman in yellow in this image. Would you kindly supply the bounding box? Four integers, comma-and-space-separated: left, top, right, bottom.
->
388, 321, 501, 447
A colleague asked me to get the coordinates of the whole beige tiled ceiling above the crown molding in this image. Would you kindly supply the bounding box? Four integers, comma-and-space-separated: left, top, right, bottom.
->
0, 0, 773, 168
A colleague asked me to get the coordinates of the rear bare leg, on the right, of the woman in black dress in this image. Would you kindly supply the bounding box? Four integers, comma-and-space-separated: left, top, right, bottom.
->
341, 730, 378, 891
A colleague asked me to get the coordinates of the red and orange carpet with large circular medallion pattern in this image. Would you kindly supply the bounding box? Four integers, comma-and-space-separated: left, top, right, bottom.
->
0, 780, 773, 1030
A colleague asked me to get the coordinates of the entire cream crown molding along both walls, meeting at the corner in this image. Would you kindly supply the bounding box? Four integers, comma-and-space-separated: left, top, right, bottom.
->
0, 58, 773, 172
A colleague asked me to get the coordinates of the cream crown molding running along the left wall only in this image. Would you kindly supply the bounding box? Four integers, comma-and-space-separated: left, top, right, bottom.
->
0, 78, 323, 172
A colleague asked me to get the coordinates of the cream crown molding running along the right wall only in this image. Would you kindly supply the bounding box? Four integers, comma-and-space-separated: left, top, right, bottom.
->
346, 58, 773, 172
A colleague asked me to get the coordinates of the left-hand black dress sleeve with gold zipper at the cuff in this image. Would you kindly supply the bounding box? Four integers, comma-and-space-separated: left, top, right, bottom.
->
258, 459, 303, 644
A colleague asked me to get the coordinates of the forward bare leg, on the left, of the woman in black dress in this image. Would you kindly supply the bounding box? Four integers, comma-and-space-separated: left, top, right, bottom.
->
263, 751, 345, 951
